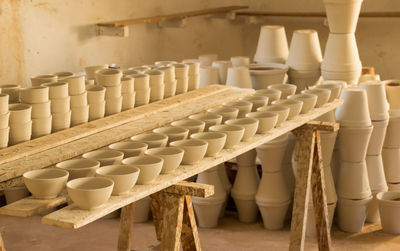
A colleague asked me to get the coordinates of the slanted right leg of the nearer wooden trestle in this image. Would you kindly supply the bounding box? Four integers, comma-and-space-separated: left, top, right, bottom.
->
181, 195, 201, 251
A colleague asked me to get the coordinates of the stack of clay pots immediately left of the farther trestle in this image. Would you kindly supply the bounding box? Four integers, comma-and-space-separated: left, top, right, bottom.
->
256, 134, 291, 230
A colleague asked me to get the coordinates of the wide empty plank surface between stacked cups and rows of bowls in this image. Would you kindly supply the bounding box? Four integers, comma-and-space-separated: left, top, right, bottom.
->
0, 85, 254, 187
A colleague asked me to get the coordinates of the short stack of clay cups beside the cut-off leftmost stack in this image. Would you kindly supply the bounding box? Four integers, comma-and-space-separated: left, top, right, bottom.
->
8, 103, 32, 146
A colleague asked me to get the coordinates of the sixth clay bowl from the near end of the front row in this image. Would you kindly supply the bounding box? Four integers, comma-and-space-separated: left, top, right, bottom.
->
190, 132, 226, 157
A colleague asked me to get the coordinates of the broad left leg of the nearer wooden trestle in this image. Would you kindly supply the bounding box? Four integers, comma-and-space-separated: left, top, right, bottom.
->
161, 193, 185, 251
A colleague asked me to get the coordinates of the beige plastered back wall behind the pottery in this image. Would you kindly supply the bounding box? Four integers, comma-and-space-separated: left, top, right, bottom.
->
0, 0, 400, 85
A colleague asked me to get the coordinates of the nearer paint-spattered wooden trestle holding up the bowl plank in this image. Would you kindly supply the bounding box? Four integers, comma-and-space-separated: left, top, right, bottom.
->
151, 181, 214, 251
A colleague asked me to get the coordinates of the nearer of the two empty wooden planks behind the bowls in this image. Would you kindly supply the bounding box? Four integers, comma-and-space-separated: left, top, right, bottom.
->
0, 87, 253, 186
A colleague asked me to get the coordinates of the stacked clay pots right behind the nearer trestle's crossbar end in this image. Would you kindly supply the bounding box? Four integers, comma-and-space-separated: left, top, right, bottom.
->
192, 166, 226, 228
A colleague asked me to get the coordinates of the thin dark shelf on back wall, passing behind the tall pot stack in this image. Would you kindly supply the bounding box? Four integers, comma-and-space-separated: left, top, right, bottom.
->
236, 11, 400, 18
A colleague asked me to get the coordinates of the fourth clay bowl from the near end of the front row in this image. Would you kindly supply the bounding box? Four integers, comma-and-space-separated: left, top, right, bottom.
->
144, 147, 184, 173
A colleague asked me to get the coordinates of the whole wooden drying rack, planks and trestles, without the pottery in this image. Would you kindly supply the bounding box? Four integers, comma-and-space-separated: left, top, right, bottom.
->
0, 86, 342, 250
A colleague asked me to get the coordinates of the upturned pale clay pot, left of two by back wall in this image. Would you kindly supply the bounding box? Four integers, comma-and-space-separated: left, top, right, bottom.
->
254, 25, 289, 64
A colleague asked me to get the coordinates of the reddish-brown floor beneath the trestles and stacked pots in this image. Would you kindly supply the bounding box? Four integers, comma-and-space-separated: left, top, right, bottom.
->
0, 215, 400, 251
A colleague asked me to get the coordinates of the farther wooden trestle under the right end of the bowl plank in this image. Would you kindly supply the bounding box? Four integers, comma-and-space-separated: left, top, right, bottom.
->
289, 122, 339, 251
